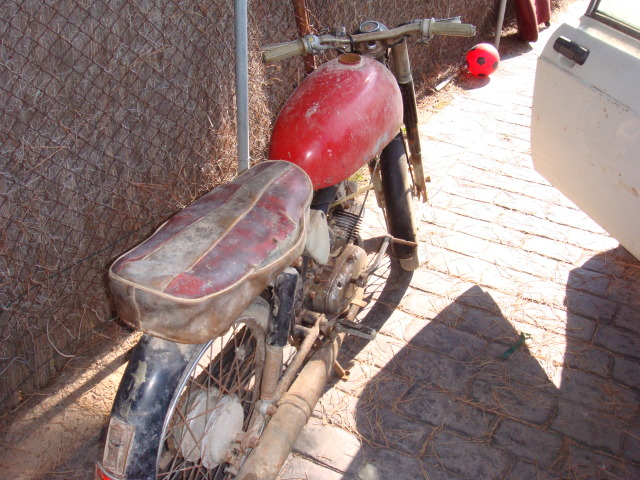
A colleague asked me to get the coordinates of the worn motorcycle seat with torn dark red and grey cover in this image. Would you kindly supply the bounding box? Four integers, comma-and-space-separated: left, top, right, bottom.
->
109, 161, 313, 343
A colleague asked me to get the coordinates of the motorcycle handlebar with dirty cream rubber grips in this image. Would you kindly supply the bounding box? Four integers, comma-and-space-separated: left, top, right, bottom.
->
262, 18, 476, 63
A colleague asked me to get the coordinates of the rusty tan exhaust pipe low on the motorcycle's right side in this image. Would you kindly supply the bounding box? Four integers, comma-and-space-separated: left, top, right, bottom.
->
236, 332, 346, 480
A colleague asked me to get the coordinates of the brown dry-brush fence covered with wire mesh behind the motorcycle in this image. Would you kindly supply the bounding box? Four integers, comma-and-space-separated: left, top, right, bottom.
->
0, 0, 513, 412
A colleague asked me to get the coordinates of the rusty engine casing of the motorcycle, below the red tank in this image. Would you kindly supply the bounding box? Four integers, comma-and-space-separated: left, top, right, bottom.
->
310, 244, 367, 315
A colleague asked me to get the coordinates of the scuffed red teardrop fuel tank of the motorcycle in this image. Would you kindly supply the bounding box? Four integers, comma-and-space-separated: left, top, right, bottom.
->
269, 53, 402, 189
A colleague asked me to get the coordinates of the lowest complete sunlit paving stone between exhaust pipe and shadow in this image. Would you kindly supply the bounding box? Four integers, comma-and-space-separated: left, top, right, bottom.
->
293, 418, 360, 472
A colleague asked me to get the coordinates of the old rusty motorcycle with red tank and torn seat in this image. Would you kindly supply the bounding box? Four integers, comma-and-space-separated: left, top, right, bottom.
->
96, 18, 475, 480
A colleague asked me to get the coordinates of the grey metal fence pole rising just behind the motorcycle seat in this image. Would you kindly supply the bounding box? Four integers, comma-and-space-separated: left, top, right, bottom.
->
235, 0, 249, 173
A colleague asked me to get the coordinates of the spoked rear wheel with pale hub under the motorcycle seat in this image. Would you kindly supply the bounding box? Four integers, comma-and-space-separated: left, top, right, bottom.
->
157, 302, 264, 480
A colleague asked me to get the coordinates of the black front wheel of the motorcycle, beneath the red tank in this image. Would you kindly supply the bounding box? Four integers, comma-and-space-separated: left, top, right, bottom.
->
380, 133, 420, 272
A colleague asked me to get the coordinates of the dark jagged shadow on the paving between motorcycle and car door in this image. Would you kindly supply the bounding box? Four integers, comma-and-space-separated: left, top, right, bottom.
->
324, 249, 640, 480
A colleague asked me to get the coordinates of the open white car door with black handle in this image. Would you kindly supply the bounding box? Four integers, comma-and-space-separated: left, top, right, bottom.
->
531, 0, 640, 259
